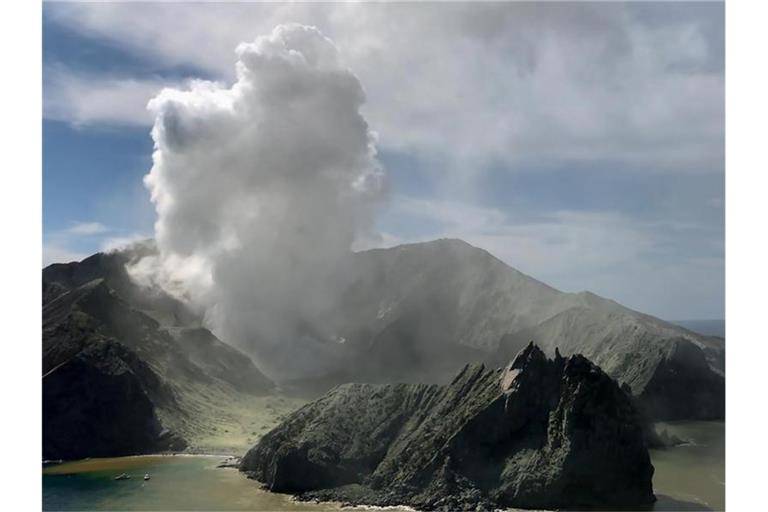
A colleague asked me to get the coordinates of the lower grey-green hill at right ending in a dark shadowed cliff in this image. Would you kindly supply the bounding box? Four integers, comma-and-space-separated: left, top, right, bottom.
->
500, 308, 725, 421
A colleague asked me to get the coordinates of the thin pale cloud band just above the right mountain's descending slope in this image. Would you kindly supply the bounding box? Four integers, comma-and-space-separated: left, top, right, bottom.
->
388, 197, 724, 318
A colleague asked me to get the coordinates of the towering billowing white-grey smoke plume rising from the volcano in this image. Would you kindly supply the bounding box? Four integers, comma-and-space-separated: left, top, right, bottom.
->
134, 24, 384, 377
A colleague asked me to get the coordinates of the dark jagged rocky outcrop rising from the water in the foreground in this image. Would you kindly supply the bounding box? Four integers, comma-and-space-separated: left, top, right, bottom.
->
240, 343, 655, 510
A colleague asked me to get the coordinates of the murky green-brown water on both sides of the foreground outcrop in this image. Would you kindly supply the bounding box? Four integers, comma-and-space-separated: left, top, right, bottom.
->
43, 422, 725, 512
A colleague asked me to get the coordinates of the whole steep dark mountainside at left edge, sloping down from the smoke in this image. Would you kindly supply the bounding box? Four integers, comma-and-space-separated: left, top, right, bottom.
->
42, 248, 272, 459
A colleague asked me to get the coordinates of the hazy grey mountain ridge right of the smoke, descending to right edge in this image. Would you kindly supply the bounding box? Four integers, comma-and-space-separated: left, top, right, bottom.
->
308, 239, 725, 419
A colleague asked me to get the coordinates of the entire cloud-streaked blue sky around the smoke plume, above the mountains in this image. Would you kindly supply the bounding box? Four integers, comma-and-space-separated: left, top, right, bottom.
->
43, 3, 725, 319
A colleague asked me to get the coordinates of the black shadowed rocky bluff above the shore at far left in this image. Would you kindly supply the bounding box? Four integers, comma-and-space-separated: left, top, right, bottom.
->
43, 339, 186, 459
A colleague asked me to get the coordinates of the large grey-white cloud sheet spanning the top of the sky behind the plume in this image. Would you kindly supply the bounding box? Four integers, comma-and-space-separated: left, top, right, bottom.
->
48, 3, 724, 173
